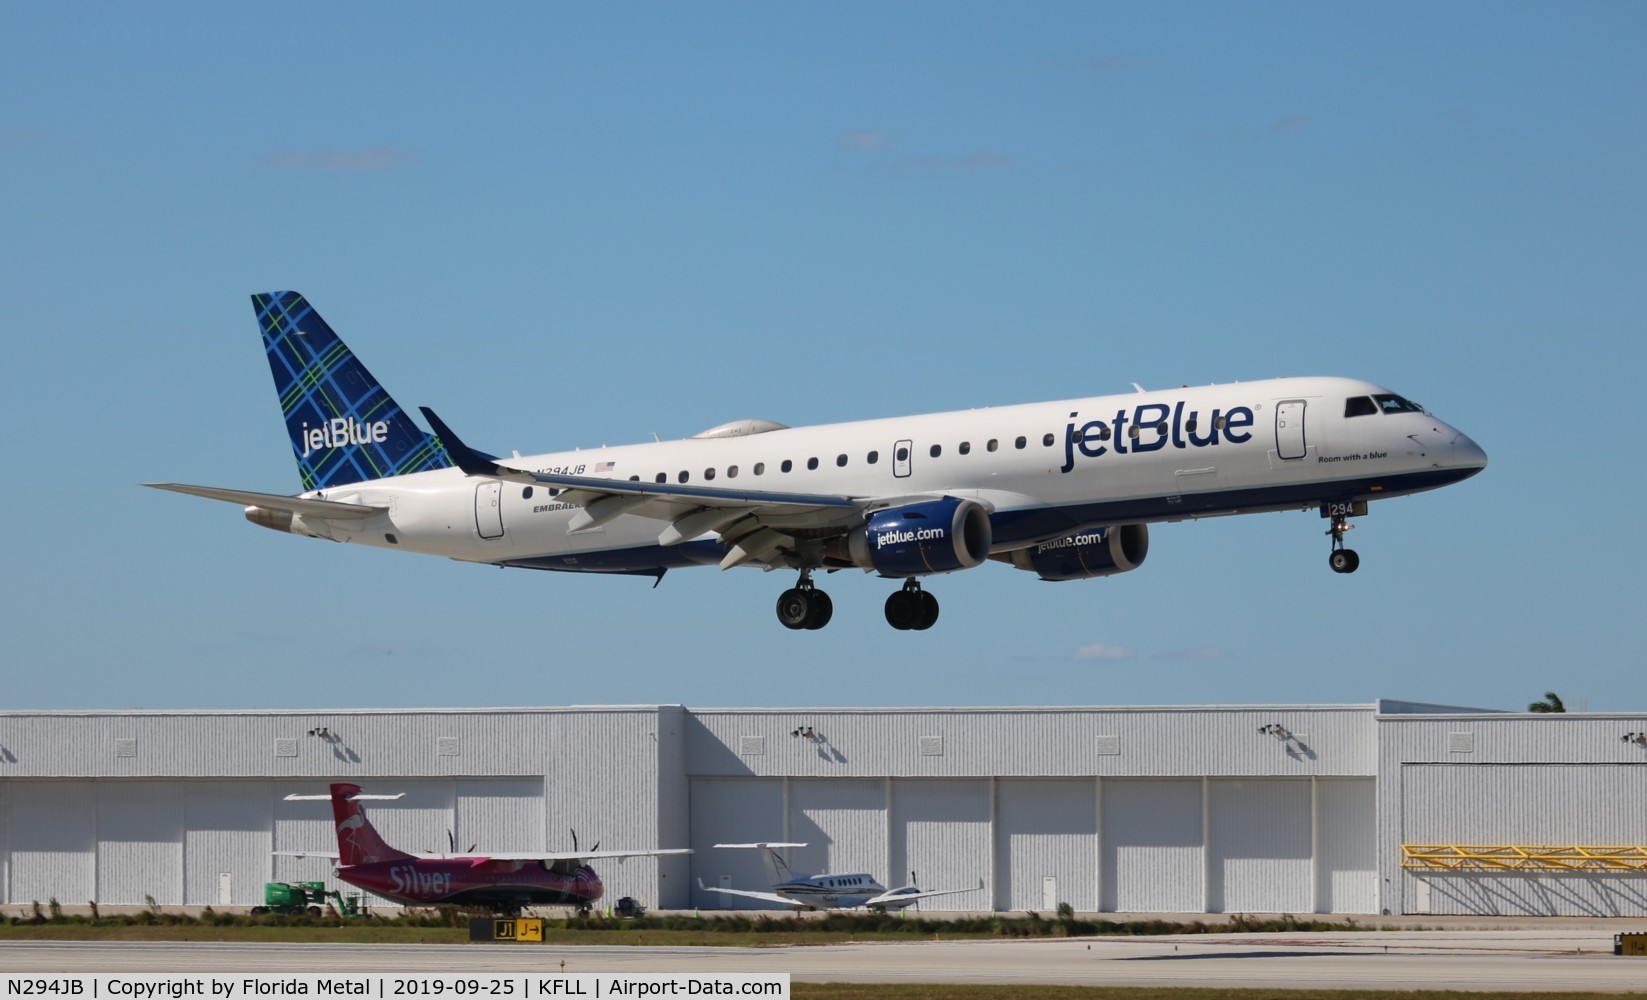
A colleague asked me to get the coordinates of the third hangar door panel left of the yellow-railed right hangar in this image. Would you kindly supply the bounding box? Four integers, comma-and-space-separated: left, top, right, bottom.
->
1102, 779, 1206, 913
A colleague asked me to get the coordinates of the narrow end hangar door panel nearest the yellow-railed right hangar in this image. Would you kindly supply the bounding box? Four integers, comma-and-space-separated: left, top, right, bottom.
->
1316, 778, 1379, 913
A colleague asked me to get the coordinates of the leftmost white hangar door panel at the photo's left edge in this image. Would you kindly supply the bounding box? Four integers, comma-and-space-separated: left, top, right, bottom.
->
10, 781, 97, 904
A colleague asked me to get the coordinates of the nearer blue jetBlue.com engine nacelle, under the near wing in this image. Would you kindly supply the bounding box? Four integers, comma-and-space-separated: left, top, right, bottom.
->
847, 496, 995, 580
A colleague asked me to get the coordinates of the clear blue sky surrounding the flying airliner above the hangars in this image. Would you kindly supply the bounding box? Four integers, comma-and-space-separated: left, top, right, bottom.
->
0, 3, 1647, 710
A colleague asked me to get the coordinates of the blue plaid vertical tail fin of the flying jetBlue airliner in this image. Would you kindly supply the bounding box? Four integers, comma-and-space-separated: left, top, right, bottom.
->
252, 292, 451, 491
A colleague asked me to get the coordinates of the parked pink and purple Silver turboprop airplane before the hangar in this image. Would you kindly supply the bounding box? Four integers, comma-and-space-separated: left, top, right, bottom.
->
273, 784, 692, 913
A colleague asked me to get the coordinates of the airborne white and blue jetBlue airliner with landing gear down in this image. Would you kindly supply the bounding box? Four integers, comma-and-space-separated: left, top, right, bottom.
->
148, 292, 1487, 629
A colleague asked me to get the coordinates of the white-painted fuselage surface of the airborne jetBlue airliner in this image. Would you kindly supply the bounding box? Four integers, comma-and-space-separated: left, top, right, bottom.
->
289, 377, 1486, 568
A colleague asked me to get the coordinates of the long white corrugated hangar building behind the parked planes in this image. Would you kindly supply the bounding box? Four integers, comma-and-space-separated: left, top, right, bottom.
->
0, 702, 1647, 916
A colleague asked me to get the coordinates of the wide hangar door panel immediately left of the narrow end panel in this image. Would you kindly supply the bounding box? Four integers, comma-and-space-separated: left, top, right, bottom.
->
1207, 779, 1314, 913
